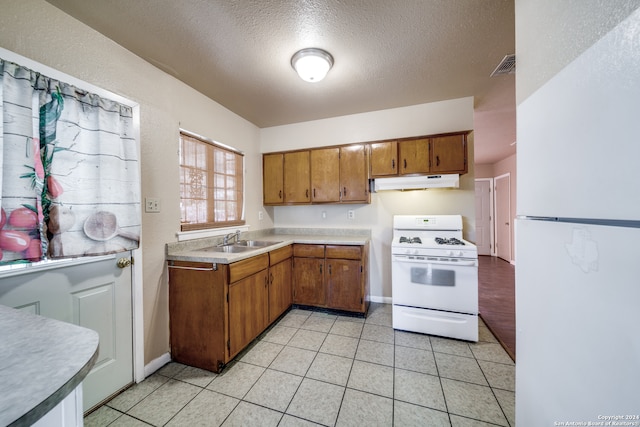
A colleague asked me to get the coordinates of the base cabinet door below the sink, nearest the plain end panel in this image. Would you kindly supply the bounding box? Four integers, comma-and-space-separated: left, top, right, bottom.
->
228, 270, 269, 358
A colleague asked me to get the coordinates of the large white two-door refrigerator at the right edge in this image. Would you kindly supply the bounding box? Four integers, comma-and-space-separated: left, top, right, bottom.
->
515, 10, 640, 427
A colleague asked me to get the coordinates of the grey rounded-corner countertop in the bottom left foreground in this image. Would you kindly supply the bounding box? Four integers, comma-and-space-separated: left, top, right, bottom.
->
0, 305, 99, 426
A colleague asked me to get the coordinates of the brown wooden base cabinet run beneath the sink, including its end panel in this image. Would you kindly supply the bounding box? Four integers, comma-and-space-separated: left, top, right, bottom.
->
169, 246, 292, 372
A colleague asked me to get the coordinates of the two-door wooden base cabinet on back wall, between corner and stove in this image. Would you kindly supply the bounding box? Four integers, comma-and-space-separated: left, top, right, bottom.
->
293, 244, 369, 314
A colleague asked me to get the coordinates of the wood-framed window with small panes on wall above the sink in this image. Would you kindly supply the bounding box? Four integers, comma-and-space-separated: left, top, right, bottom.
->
180, 131, 244, 231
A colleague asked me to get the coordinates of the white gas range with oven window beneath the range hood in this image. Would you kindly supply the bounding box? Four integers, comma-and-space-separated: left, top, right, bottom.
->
391, 215, 478, 341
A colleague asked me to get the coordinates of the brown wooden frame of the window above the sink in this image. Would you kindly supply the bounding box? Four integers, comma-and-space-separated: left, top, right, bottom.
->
178, 129, 246, 232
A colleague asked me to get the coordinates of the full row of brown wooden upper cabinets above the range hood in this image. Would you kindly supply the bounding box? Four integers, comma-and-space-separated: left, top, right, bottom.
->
262, 131, 468, 205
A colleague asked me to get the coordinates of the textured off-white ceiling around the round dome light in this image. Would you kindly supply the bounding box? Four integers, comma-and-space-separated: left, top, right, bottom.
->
47, 0, 515, 163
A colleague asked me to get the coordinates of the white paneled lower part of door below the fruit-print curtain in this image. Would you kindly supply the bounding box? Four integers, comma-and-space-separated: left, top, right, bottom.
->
0, 252, 133, 411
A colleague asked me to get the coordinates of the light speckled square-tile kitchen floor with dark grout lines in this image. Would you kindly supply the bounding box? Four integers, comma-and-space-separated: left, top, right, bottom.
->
85, 304, 515, 427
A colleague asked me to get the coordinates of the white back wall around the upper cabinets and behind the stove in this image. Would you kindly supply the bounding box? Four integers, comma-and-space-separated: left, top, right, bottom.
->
260, 98, 475, 302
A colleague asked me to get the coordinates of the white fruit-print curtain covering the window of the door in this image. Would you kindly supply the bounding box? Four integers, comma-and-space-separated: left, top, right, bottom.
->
0, 59, 140, 264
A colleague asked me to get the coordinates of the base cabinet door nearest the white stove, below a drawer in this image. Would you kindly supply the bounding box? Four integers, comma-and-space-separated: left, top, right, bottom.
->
327, 259, 364, 311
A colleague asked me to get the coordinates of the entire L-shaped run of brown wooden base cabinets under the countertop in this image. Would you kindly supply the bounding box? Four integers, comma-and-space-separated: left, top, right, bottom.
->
169, 244, 369, 372
